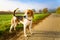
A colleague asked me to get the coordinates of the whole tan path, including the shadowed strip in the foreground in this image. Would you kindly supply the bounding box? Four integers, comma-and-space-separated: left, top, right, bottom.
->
11, 14, 60, 40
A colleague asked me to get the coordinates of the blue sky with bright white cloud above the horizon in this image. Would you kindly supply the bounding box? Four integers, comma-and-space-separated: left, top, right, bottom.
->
0, 0, 60, 11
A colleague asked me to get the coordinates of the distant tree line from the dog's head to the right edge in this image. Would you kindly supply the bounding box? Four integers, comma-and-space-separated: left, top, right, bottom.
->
32, 7, 60, 14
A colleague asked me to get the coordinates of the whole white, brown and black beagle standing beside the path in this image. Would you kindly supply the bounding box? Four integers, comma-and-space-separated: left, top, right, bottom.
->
9, 8, 34, 37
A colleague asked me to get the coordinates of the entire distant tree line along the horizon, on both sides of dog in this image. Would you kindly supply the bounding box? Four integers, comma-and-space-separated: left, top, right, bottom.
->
0, 7, 60, 14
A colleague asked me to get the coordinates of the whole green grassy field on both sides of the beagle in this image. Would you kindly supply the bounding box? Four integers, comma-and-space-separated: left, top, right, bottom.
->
0, 14, 49, 35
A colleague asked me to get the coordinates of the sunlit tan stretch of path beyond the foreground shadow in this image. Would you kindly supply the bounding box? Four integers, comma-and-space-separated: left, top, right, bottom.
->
34, 14, 60, 32
